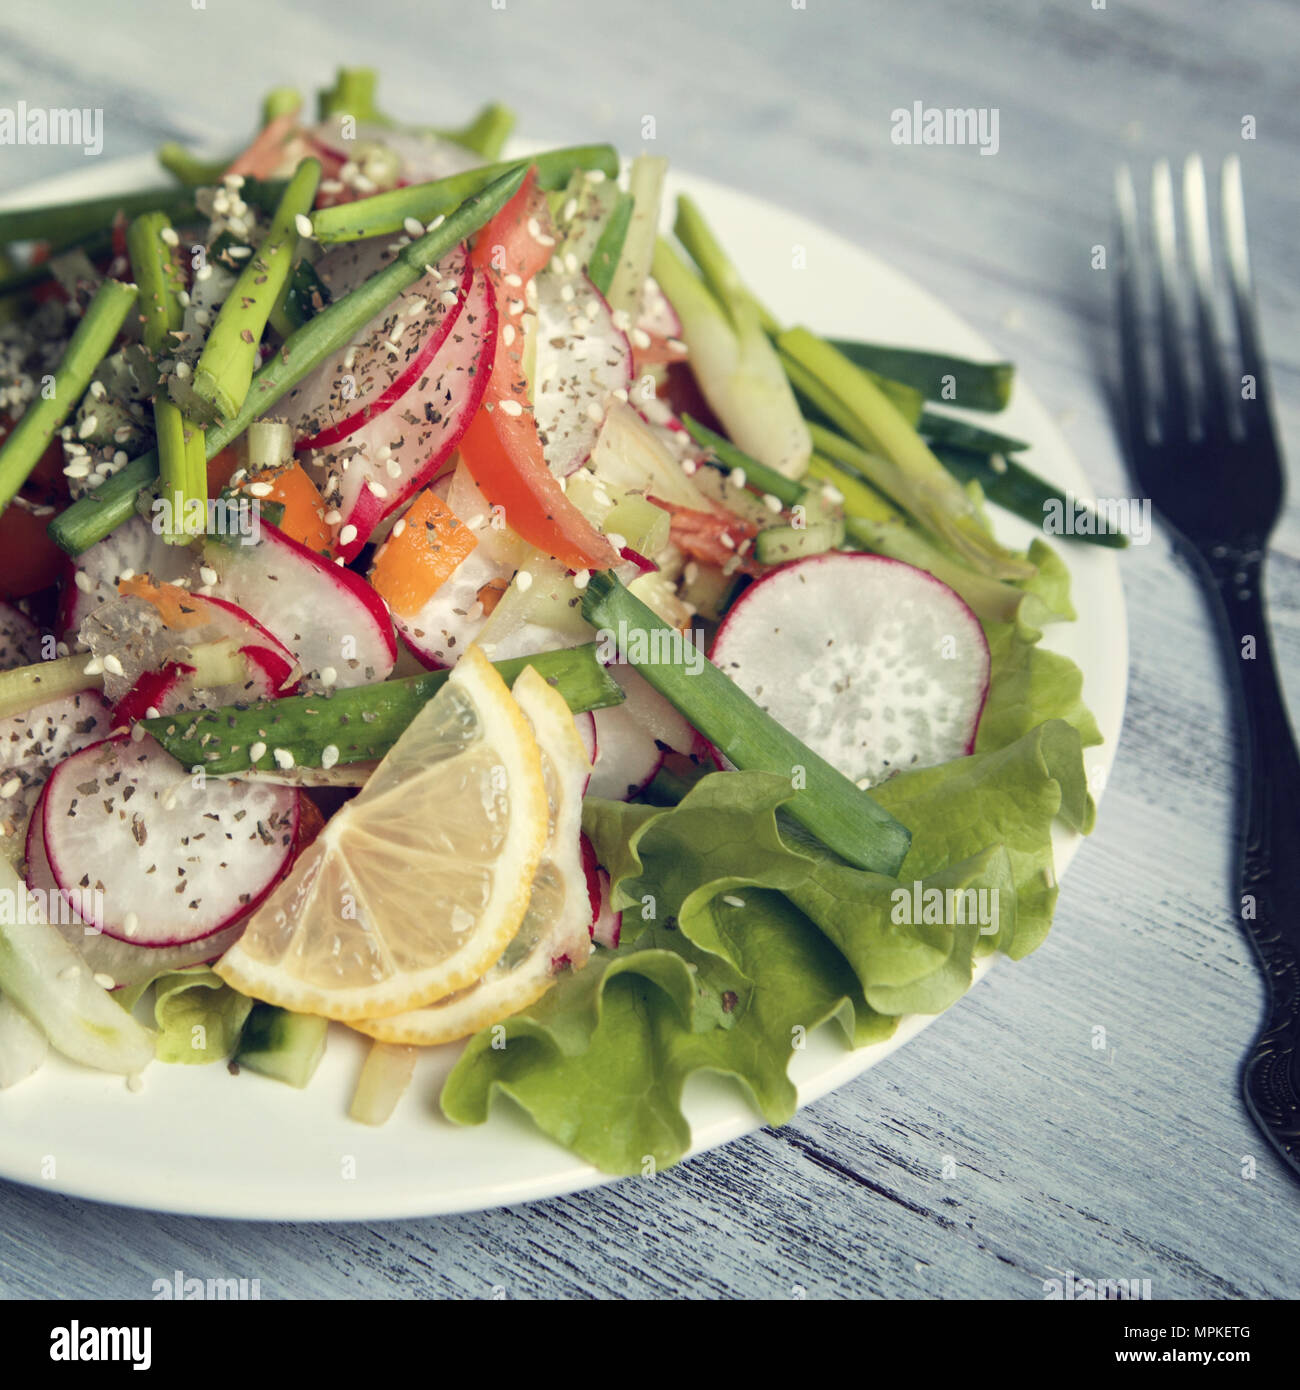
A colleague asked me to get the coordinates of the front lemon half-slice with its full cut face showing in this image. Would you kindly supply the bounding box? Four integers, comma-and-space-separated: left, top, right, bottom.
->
214, 648, 548, 1020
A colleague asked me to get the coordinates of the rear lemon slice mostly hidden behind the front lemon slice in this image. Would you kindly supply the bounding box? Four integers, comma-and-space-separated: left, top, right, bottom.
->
352, 666, 591, 1045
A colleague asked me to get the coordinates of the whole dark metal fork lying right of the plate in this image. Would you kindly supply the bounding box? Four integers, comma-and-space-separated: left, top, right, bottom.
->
1116, 156, 1300, 1177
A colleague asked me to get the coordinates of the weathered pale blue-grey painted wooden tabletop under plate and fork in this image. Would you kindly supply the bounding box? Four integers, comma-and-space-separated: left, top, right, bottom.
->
0, 0, 1300, 1298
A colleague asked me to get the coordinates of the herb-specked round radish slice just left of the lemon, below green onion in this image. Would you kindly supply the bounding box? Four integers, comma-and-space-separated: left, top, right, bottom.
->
42, 735, 299, 947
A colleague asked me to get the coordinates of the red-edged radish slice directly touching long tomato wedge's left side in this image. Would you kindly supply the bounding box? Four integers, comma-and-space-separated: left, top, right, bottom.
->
302, 272, 496, 560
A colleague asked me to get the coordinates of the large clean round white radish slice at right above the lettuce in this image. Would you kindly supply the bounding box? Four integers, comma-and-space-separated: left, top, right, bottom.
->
710, 555, 989, 784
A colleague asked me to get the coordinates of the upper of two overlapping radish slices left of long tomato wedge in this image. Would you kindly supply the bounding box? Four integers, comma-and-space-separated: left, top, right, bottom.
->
284, 238, 473, 452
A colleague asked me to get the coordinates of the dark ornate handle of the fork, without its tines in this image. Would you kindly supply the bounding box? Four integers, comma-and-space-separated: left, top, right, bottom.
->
1203, 541, 1300, 1166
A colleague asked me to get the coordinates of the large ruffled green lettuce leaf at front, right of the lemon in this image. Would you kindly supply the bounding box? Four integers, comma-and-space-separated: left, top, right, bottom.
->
442, 720, 1093, 1173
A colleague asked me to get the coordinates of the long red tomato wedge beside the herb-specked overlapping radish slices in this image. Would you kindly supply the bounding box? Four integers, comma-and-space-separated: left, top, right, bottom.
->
460, 168, 619, 570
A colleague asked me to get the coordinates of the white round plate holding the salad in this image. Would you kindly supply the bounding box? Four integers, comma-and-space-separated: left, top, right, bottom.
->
0, 158, 1128, 1220
